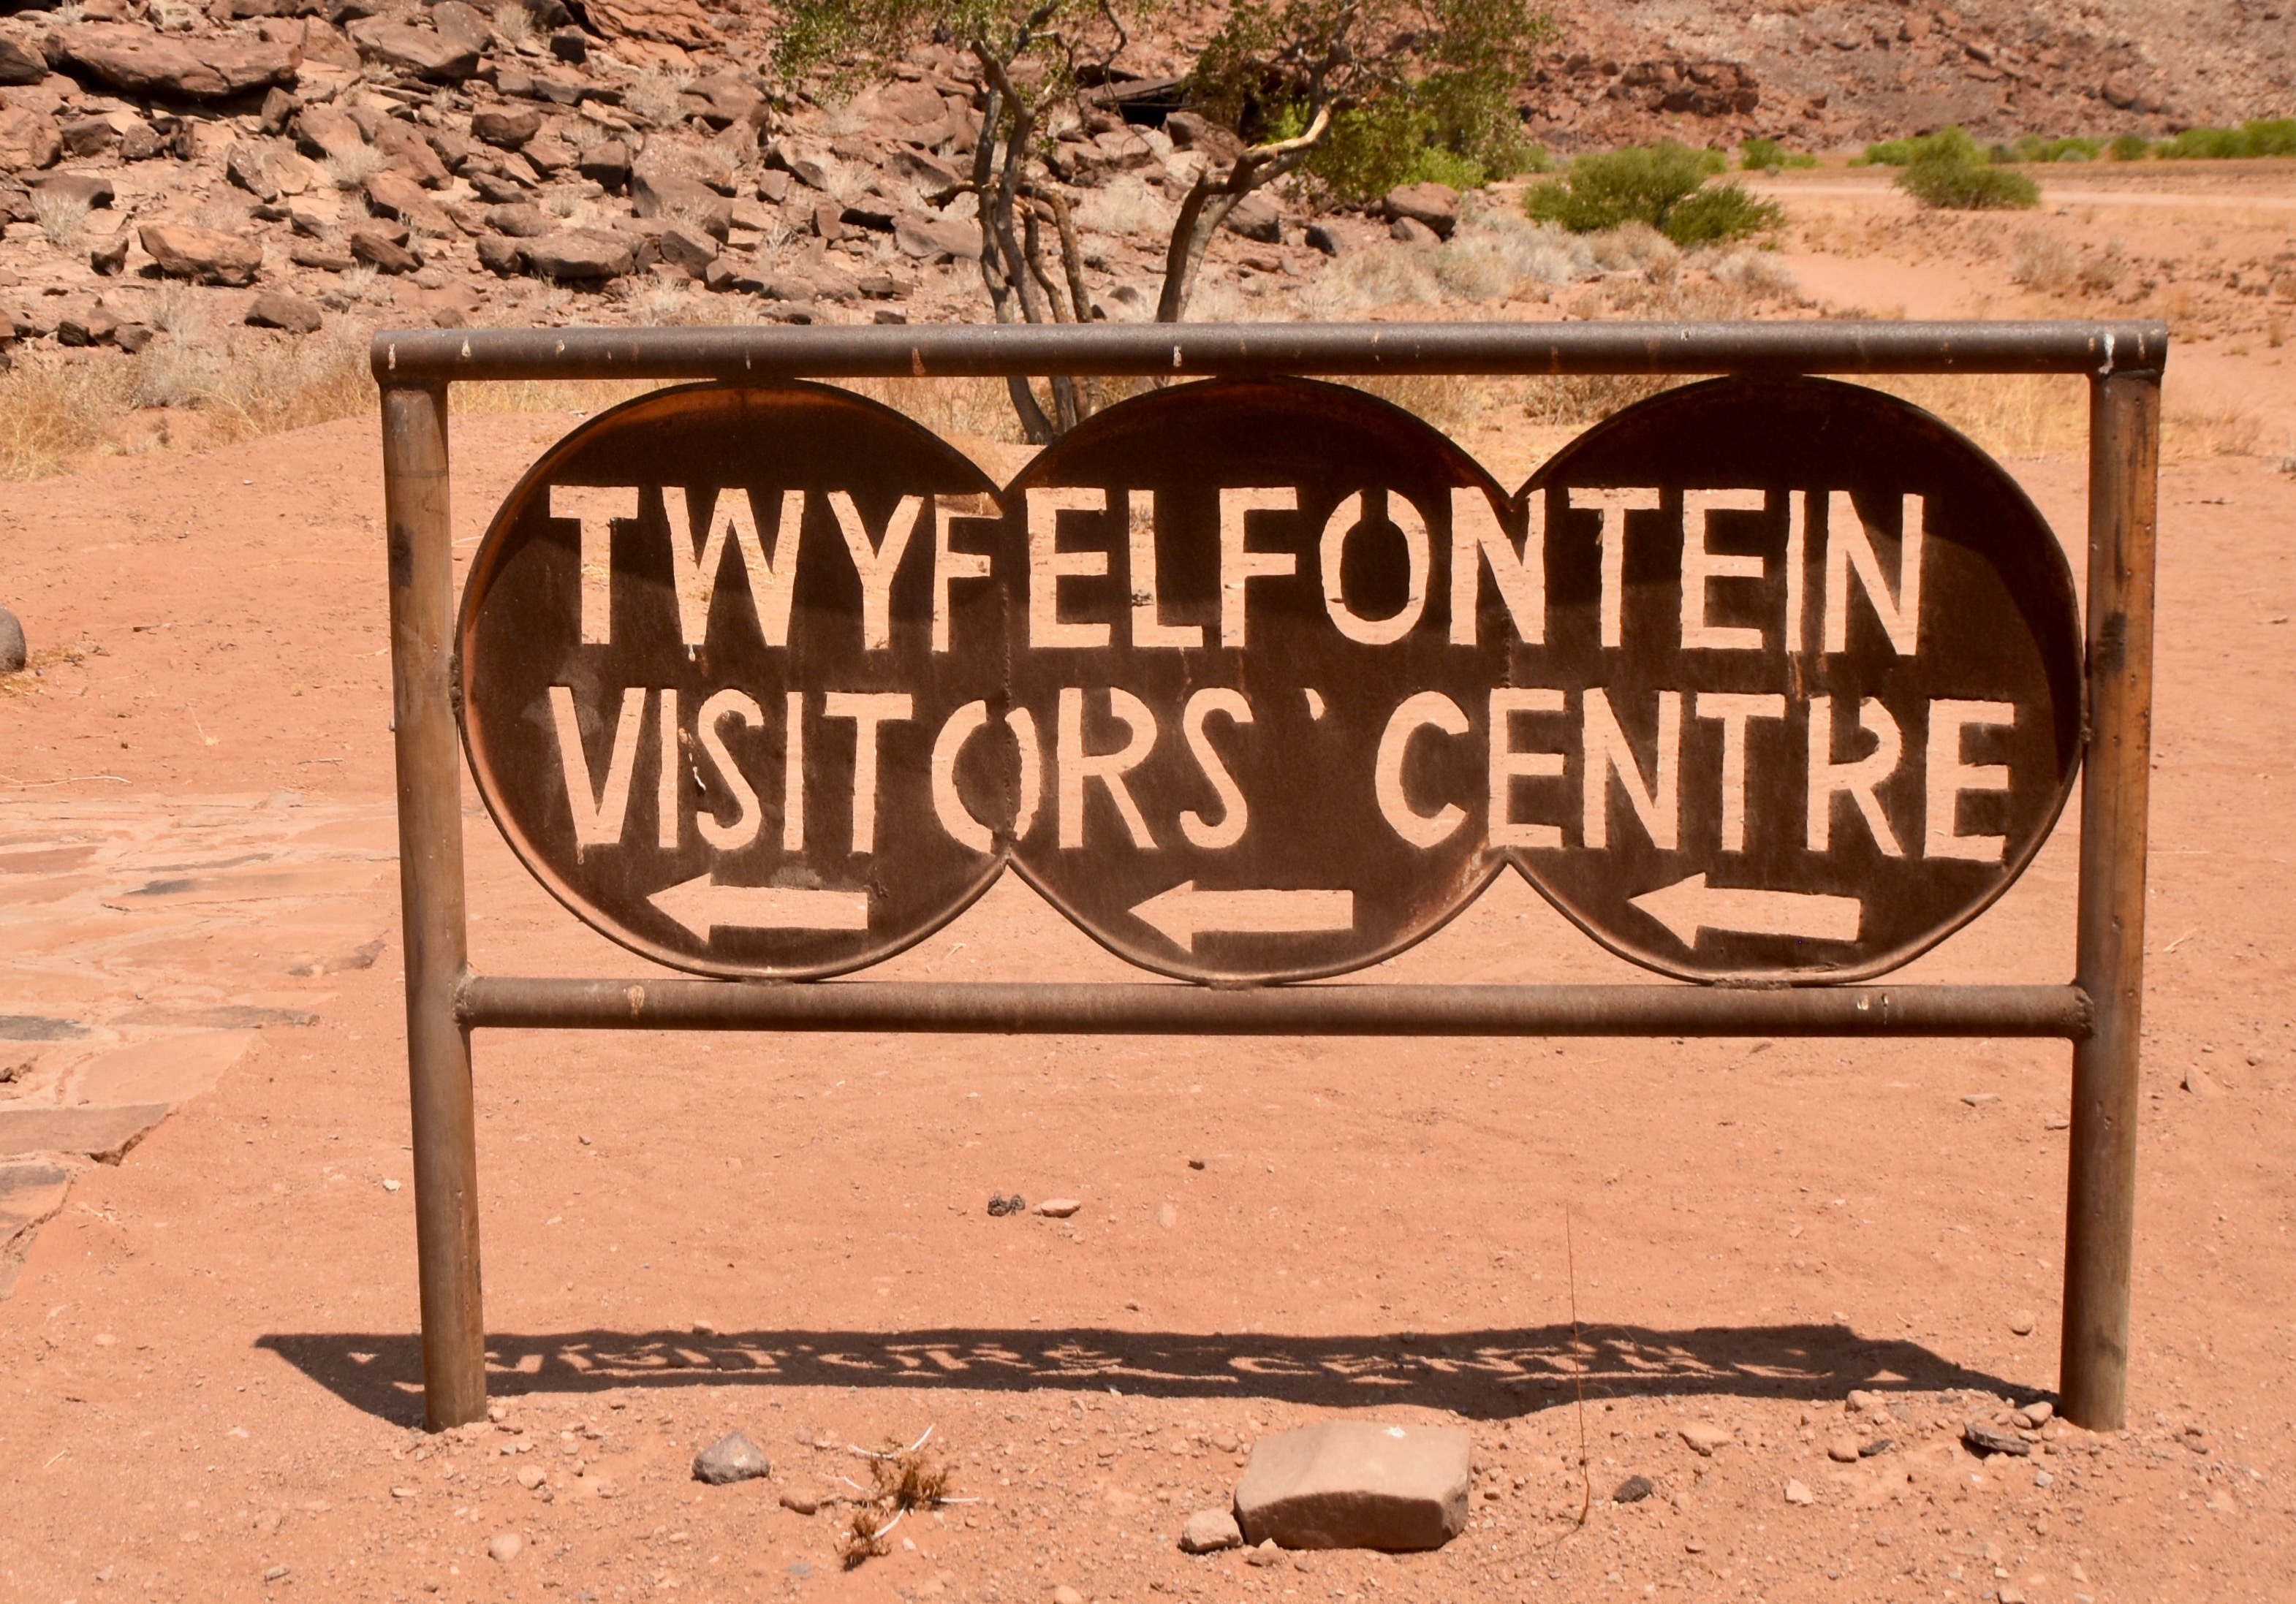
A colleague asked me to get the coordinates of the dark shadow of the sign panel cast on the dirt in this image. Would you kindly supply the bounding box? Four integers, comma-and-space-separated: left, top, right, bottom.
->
257, 1324, 2030, 1425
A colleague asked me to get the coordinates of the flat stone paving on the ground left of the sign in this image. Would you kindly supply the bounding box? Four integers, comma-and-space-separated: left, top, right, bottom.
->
0, 791, 397, 1299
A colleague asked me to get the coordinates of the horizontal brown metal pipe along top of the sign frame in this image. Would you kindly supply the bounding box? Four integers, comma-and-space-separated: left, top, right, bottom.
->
374, 322, 2167, 388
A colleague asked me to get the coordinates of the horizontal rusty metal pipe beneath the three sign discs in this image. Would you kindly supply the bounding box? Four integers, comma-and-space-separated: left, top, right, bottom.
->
457, 976, 2091, 1042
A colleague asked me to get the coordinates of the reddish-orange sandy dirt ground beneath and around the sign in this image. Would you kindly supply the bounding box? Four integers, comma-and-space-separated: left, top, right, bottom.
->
0, 172, 2296, 1604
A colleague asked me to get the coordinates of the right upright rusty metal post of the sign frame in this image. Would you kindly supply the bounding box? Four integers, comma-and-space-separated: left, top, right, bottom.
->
2057, 372, 2161, 1432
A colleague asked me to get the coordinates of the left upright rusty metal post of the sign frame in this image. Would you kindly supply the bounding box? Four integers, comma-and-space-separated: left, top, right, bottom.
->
384, 386, 487, 1432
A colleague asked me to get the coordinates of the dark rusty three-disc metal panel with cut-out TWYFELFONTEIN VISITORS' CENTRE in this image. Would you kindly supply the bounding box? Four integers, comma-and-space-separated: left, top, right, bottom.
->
459, 379, 2080, 984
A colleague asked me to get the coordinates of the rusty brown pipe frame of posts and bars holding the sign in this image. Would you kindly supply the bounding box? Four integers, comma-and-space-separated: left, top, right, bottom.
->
374, 324, 2167, 1429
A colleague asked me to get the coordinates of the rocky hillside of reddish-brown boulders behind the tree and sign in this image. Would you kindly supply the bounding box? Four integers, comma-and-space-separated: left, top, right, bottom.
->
0, 0, 2296, 406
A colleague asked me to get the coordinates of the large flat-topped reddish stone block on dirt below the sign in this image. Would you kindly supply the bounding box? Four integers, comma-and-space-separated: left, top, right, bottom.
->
1235, 1421, 1471, 1554
